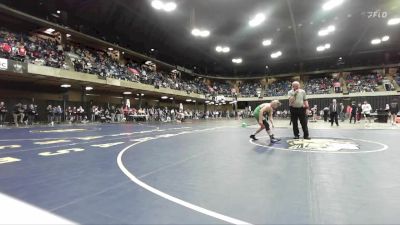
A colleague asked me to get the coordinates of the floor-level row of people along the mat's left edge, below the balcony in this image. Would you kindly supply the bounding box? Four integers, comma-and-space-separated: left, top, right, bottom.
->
0, 102, 242, 127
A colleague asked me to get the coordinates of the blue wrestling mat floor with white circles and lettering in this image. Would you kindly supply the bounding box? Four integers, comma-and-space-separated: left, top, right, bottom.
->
0, 120, 400, 224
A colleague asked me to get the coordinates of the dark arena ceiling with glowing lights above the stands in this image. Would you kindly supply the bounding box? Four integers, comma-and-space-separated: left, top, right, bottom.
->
2, 0, 400, 76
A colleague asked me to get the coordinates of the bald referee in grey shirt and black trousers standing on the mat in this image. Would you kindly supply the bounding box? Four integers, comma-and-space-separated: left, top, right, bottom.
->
288, 81, 310, 140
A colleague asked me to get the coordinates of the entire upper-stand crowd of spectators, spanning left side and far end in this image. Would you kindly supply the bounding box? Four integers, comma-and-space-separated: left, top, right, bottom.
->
0, 28, 400, 97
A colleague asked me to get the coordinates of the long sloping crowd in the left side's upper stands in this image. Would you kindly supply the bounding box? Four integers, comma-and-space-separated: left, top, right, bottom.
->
0, 28, 214, 94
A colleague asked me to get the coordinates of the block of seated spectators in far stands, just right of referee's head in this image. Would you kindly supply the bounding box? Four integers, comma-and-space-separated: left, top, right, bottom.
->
304, 77, 338, 94
